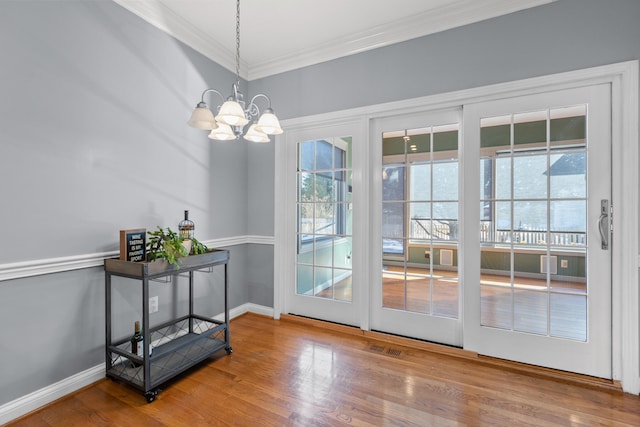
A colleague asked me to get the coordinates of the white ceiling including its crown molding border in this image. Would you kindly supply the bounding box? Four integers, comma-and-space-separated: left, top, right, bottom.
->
113, 0, 555, 80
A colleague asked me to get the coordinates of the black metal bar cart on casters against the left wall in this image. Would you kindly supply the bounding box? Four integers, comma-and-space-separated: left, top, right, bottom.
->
104, 249, 232, 403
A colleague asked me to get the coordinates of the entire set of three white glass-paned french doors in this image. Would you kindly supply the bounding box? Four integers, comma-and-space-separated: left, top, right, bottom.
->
282, 84, 612, 378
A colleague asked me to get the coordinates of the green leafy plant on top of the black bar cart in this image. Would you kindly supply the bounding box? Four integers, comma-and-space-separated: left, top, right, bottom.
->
147, 226, 207, 267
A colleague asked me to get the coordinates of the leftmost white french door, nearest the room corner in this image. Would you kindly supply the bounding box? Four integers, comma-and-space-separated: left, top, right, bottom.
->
283, 121, 364, 326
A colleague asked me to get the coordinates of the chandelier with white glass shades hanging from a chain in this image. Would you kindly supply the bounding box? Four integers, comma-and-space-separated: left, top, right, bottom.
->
187, 0, 282, 142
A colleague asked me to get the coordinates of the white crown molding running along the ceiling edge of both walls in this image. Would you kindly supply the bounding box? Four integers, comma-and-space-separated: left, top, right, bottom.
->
113, 0, 557, 81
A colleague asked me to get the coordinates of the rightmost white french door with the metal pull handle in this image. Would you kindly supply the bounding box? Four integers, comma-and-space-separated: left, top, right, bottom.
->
462, 84, 612, 378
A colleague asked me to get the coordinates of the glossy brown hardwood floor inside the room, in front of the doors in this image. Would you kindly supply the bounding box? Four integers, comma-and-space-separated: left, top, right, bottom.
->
8, 314, 640, 427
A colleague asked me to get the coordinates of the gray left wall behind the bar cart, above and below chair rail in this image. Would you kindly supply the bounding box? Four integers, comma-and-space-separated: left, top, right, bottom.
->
0, 0, 251, 405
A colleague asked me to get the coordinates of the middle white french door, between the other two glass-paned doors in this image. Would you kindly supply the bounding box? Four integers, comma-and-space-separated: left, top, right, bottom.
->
370, 109, 462, 346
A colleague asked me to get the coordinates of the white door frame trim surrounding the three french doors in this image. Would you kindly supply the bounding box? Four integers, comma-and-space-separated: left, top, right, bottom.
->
274, 60, 640, 394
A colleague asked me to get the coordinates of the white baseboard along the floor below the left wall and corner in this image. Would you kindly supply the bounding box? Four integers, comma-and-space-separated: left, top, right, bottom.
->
0, 303, 273, 425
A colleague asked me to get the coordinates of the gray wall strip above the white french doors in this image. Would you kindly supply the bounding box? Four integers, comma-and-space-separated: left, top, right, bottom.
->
250, 0, 640, 118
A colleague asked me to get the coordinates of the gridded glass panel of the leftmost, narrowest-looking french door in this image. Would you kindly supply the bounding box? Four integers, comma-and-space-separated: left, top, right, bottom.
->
296, 137, 353, 302
